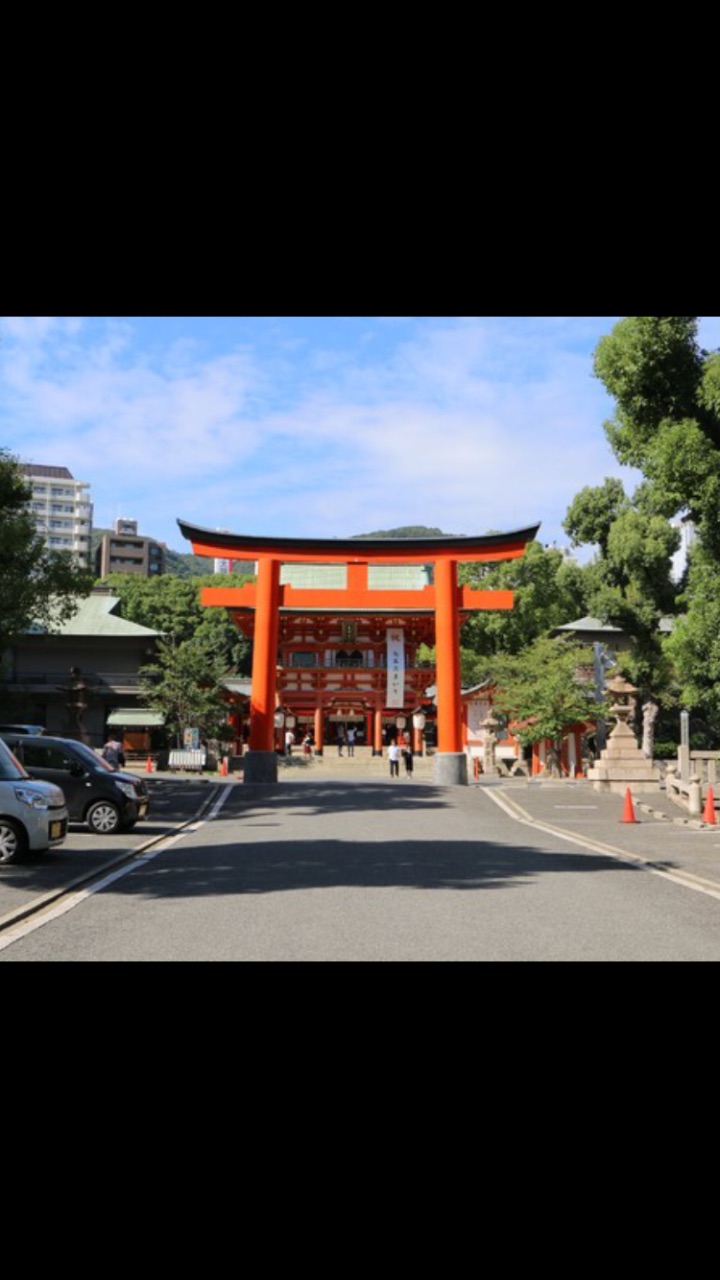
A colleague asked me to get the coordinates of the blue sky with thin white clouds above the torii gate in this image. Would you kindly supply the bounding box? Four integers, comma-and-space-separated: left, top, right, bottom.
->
0, 316, 720, 550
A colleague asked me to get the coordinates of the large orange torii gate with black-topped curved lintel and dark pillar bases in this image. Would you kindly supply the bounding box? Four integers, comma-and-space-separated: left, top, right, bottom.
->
178, 520, 539, 783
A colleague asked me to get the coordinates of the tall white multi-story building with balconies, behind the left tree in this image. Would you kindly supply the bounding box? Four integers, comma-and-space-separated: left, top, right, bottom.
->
20, 462, 92, 568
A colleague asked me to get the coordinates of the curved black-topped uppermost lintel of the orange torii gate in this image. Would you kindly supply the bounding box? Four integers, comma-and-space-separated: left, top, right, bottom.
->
178, 520, 539, 562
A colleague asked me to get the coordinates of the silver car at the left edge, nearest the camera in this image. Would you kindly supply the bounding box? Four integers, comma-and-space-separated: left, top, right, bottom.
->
0, 739, 68, 863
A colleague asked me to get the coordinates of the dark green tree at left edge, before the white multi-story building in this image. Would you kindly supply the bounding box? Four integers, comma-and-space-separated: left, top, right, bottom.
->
0, 449, 92, 655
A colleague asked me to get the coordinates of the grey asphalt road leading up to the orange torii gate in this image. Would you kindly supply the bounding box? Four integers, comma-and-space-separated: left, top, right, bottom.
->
0, 774, 720, 963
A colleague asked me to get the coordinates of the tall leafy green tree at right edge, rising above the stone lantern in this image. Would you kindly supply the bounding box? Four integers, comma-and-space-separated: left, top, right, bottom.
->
565, 316, 720, 732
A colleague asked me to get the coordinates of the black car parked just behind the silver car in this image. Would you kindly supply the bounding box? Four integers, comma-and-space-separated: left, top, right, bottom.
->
0, 731, 147, 836
